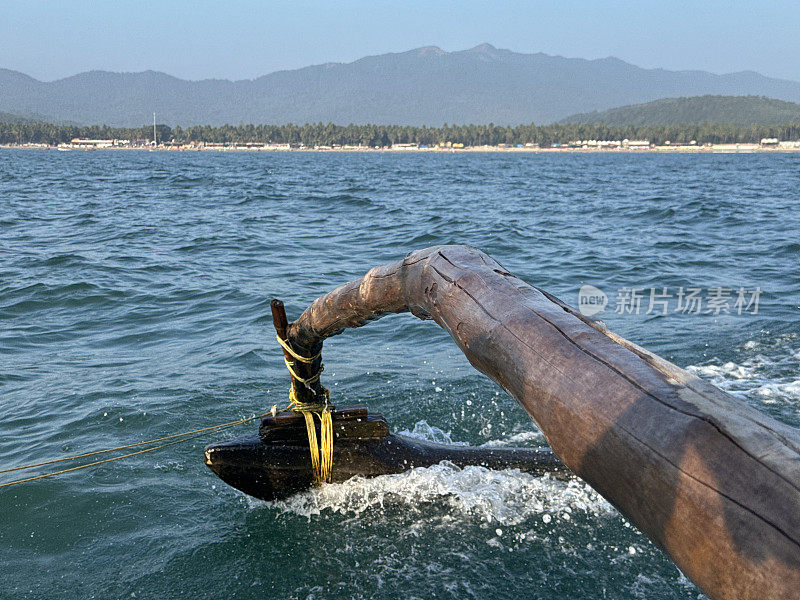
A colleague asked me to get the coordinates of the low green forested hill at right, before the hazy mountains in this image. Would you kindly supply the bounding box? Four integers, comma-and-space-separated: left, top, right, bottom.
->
562, 96, 800, 127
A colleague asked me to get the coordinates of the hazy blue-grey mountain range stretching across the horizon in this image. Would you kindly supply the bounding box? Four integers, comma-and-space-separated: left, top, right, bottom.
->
0, 44, 800, 127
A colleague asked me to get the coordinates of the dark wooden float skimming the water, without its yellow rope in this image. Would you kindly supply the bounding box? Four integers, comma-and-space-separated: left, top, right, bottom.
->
205, 406, 568, 500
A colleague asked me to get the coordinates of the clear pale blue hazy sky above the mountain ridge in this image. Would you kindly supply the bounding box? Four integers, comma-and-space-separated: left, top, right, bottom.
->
6, 0, 800, 80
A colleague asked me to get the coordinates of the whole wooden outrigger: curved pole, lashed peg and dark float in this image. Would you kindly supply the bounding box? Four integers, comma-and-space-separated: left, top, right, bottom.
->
206, 246, 800, 600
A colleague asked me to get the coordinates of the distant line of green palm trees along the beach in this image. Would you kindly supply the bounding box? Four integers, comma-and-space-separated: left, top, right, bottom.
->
0, 121, 800, 147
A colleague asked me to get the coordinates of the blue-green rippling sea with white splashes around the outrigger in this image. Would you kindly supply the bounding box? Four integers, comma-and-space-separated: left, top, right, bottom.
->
0, 150, 800, 600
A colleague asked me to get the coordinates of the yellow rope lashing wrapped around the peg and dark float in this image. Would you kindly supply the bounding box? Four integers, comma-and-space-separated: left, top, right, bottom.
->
276, 336, 333, 483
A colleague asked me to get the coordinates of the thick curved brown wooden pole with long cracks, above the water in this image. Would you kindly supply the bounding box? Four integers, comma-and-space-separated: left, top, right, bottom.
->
288, 246, 800, 600
